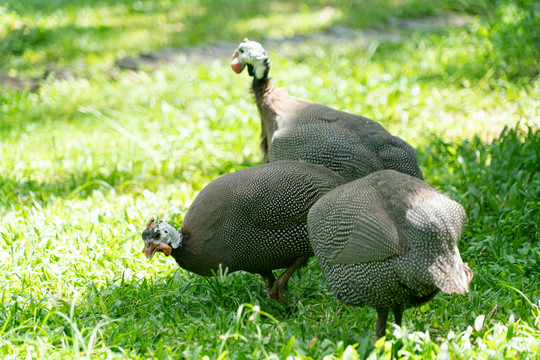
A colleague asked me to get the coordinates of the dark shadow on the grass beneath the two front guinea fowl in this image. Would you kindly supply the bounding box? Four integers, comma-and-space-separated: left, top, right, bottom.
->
58, 262, 372, 355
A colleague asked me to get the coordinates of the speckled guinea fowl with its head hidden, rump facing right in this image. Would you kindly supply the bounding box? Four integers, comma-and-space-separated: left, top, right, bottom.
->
308, 170, 473, 338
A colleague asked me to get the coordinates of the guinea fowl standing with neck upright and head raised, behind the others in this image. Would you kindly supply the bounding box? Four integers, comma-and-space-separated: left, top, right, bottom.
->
231, 39, 423, 181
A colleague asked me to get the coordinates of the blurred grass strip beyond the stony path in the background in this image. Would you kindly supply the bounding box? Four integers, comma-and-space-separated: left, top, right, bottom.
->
5, 0, 540, 79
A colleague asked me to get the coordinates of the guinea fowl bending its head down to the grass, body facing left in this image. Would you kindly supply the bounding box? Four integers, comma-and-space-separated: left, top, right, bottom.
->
142, 161, 345, 300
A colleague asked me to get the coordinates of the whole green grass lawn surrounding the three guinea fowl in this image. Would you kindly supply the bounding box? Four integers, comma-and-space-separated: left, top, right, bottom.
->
0, 0, 540, 359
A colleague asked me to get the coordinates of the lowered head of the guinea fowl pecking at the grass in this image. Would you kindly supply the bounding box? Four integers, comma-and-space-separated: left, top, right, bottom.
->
142, 218, 183, 260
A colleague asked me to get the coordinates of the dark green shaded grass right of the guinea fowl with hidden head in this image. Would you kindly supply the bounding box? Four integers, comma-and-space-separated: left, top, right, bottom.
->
424, 128, 540, 316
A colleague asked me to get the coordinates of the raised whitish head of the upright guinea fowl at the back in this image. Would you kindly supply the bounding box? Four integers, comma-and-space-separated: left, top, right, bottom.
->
231, 39, 270, 79
